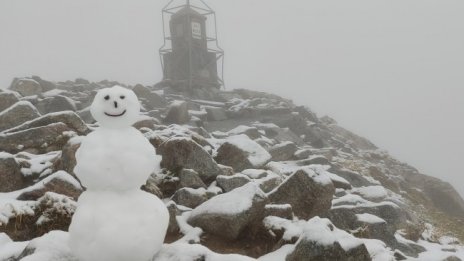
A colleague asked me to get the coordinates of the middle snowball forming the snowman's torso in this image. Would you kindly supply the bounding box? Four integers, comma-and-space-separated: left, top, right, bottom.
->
74, 127, 161, 190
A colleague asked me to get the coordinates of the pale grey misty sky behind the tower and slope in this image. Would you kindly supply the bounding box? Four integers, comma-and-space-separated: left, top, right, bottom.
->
0, 0, 464, 195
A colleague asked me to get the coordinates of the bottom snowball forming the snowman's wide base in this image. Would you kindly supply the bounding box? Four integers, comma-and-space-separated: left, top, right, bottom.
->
69, 190, 169, 261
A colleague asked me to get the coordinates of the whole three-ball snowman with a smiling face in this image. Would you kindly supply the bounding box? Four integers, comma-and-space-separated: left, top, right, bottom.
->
69, 86, 169, 261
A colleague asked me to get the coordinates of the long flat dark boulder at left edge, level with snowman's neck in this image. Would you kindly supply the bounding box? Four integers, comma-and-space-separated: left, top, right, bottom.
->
0, 122, 72, 153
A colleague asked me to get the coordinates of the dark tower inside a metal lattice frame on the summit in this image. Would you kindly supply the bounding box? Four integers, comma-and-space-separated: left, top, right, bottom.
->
159, 0, 224, 89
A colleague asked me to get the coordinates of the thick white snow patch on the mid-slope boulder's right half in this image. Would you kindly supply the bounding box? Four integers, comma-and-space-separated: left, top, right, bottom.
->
226, 134, 272, 167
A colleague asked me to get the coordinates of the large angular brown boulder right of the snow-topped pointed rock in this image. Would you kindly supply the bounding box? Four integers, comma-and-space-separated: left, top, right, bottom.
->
268, 168, 335, 219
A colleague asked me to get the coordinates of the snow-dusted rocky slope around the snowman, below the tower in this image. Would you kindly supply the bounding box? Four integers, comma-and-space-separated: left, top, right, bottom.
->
0, 76, 464, 261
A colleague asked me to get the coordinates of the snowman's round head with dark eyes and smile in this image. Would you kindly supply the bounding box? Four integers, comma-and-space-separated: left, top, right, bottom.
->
90, 85, 140, 129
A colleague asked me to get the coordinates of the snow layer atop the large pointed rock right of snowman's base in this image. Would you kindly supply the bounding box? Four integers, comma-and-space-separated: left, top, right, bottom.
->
191, 183, 266, 218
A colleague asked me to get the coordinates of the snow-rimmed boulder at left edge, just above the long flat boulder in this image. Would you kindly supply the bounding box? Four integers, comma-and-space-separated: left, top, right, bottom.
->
0, 101, 40, 132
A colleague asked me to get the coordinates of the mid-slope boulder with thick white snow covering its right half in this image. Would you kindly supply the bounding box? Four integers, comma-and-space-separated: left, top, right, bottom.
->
215, 134, 271, 171
